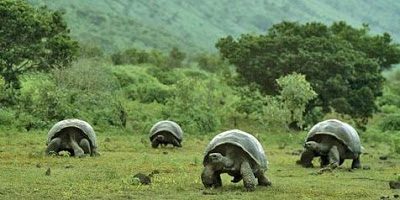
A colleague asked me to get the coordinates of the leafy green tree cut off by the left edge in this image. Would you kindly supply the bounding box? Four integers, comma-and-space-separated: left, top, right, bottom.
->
0, 0, 78, 88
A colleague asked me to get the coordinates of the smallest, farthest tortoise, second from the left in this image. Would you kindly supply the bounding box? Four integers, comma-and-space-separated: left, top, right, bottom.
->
149, 120, 183, 148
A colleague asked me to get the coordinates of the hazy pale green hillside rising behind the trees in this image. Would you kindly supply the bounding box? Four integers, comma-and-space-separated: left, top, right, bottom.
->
28, 0, 400, 52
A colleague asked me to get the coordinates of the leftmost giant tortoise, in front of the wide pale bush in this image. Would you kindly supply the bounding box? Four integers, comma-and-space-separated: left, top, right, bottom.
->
46, 119, 100, 157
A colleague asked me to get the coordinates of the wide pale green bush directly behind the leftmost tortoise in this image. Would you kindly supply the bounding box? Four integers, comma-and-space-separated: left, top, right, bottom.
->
18, 60, 125, 128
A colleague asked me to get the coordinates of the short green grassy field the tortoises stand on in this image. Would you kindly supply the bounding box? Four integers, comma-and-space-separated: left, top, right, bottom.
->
0, 131, 400, 199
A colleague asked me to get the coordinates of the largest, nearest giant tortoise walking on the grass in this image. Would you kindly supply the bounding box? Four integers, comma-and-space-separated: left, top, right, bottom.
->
201, 129, 271, 190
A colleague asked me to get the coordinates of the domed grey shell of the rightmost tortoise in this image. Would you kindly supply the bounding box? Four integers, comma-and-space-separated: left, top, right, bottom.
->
306, 119, 363, 154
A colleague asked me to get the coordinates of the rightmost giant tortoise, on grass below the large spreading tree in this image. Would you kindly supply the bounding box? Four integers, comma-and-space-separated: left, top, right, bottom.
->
298, 119, 363, 169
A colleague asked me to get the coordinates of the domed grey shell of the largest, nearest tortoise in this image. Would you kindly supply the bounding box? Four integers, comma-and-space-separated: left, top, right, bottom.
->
203, 129, 268, 170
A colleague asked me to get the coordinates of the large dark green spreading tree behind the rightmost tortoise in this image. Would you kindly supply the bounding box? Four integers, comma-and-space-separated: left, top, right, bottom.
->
216, 22, 400, 123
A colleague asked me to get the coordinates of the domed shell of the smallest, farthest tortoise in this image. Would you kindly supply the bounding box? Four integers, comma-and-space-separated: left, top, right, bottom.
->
149, 120, 183, 142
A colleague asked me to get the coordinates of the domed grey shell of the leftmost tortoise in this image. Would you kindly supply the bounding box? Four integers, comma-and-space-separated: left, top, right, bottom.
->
46, 119, 97, 147
